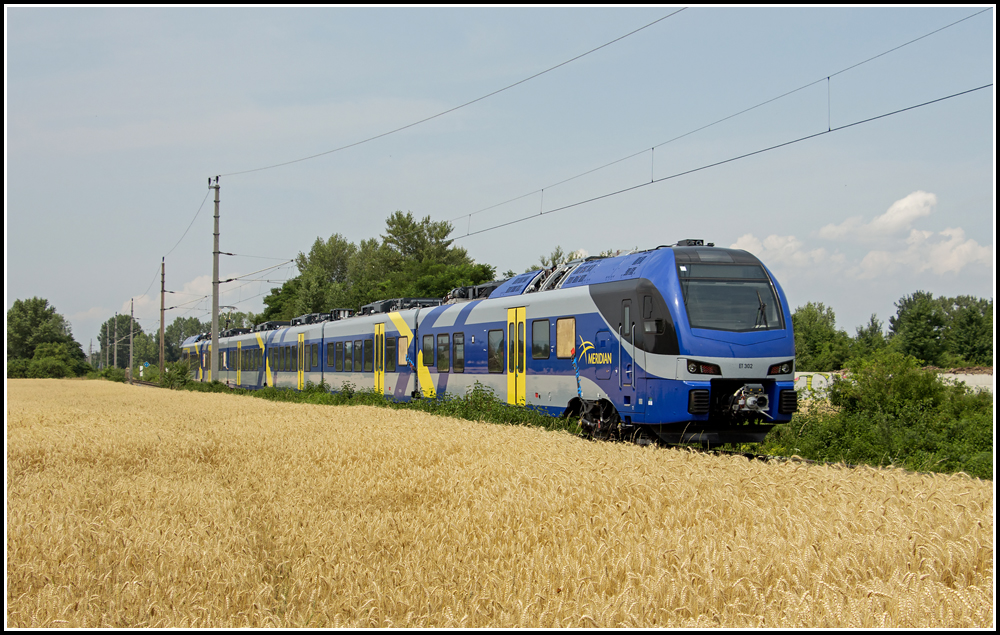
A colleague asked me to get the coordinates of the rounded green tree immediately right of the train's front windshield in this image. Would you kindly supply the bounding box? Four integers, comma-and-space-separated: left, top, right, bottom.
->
792, 302, 851, 372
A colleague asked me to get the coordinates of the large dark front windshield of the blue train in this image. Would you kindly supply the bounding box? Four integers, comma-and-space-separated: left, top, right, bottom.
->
677, 263, 785, 331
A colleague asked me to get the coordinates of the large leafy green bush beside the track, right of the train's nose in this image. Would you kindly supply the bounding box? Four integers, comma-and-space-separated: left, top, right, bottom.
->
764, 349, 993, 478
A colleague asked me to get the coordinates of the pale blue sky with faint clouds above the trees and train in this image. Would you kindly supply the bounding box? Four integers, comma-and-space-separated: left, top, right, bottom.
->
4, 5, 996, 351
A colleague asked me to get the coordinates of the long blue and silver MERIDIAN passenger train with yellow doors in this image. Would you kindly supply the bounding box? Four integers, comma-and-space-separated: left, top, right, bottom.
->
182, 240, 797, 445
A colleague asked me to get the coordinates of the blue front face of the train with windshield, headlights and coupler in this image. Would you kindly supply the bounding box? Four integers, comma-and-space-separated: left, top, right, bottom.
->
647, 248, 797, 444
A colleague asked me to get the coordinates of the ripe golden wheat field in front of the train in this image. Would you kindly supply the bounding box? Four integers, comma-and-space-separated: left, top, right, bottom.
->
7, 380, 994, 628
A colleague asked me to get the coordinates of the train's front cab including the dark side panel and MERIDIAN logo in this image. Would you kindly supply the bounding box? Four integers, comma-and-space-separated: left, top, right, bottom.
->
580, 247, 795, 444
